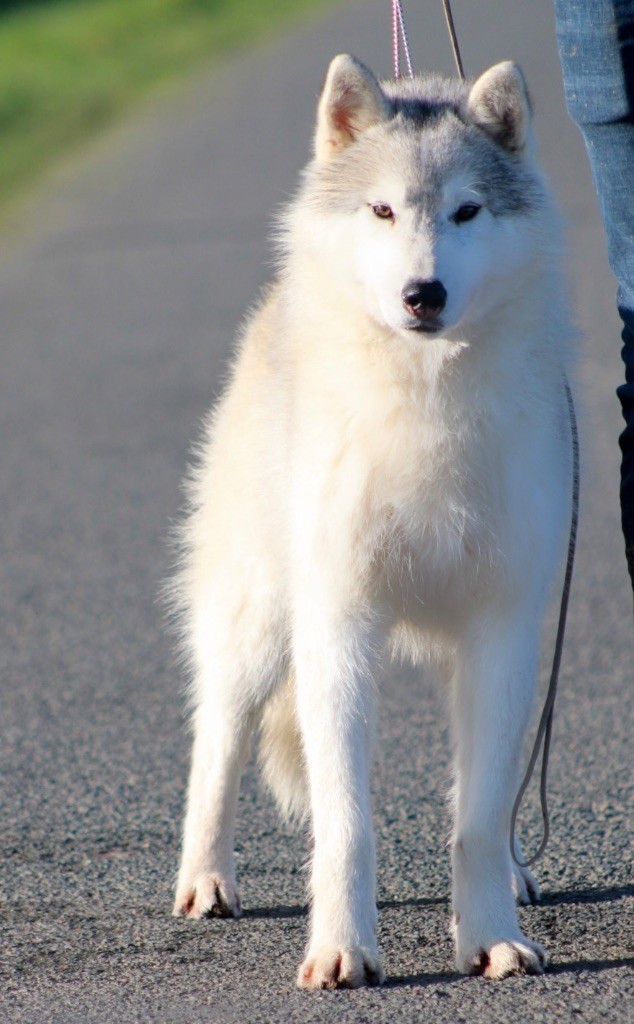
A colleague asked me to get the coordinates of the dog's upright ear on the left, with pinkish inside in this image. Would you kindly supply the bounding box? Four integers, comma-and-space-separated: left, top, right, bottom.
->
314, 53, 389, 163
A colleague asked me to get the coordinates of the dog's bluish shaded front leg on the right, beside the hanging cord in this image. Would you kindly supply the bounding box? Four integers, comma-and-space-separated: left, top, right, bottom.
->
452, 609, 544, 978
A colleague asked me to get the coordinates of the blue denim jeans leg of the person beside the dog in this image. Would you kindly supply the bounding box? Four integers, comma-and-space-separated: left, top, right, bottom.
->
554, 0, 634, 586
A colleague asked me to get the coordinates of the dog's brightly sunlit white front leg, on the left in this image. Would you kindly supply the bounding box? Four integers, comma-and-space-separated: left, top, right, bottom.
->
295, 593, 384, 988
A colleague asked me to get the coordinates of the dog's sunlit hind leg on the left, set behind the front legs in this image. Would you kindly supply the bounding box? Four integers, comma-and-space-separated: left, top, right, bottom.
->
174, 596, 284, 918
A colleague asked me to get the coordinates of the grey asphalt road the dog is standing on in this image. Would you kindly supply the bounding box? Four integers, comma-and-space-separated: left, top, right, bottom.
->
0, 0, 634, 1024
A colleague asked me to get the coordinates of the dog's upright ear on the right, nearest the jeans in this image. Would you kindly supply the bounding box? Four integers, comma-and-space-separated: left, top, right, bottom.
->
468, 60, 533, 155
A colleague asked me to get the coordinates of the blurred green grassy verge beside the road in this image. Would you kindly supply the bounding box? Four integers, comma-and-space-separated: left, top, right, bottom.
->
0, 0, 334, 205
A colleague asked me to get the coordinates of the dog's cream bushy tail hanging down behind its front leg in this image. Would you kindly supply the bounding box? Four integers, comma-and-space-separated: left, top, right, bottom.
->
259, 676, 308, 821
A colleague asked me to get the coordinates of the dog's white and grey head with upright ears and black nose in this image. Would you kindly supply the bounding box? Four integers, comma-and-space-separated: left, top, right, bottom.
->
294, 55, 549, 337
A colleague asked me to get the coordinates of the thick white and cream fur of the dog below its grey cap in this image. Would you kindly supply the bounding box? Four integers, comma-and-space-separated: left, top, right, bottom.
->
170, 58, 570, 988
